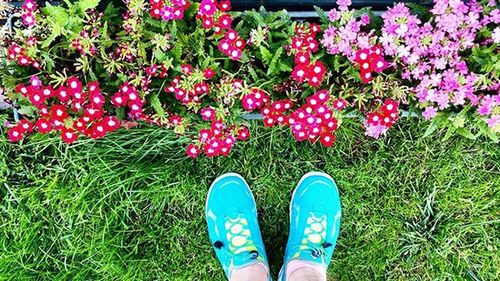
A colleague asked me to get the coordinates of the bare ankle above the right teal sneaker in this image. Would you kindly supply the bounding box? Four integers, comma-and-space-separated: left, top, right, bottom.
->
285, 259, 326, 281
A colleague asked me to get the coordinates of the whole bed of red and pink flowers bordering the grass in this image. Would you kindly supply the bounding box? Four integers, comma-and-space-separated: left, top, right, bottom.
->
0, 0, 500, 157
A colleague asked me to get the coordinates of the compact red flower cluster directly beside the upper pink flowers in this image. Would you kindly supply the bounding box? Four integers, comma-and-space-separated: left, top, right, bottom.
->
356, 46, 387, 84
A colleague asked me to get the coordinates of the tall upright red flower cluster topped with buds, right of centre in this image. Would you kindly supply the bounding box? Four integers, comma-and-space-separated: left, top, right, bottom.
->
289, 23, 326, 87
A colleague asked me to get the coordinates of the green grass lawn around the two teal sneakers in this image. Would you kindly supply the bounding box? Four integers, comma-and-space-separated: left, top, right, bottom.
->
0, 121, 500, 280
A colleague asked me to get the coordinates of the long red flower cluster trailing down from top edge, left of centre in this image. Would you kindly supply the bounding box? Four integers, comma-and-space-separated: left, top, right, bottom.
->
196, 0, 246, 60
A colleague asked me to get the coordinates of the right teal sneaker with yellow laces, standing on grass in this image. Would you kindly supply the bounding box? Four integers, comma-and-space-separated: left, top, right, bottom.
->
278, 172, 341, 280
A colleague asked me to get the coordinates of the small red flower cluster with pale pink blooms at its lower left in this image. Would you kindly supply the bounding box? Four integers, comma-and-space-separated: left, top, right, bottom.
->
364, 99, 399, 139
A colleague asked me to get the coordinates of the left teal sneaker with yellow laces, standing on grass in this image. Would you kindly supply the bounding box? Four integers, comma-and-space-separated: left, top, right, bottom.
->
205, 173, 270, 280
